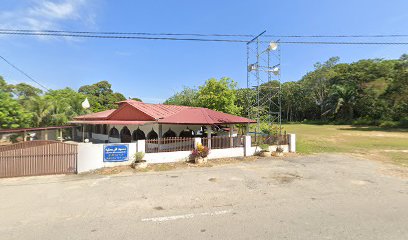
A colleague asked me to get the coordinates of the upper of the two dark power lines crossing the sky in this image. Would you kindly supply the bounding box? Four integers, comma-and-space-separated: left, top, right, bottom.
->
0, 29, 408, 38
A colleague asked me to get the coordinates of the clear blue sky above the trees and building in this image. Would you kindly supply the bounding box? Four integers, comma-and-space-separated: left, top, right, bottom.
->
0, 0, 408, 102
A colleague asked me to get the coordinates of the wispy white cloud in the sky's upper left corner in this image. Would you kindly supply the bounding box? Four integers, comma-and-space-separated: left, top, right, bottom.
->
0, 0, 96, 38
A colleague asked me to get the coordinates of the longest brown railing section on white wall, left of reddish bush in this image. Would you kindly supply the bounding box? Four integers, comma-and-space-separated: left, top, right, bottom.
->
145, 137, 194, 153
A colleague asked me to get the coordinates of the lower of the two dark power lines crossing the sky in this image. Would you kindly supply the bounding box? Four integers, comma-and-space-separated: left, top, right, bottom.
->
0, 30, 408, 45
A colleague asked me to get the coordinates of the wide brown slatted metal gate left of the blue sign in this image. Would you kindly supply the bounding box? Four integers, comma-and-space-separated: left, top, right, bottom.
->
0, 141, 78, 178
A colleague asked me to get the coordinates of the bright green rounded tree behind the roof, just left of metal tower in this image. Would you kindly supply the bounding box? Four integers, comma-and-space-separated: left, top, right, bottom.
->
197, 77, 241, 114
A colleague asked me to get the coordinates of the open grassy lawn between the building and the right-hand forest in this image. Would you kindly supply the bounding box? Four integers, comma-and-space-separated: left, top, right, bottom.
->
284, 124, 408, 167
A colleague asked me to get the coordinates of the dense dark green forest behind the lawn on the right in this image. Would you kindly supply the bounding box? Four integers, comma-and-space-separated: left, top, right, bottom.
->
282, 54, 408, 123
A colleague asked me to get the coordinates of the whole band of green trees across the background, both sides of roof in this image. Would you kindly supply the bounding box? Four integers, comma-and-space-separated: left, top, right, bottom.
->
0, 54, 408, 128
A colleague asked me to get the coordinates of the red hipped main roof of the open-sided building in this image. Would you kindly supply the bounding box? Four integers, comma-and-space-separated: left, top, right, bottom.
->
71, 100, 256, 125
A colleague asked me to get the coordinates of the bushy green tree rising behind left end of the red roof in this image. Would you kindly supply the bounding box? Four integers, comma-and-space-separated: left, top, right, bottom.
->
78, 81, 126, 112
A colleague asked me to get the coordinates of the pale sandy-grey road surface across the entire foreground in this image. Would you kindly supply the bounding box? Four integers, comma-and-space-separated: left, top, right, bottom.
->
0, 155, 408, 240
